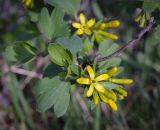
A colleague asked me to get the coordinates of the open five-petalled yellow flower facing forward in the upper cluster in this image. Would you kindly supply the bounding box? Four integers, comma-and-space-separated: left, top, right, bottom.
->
72, 13, 95, 35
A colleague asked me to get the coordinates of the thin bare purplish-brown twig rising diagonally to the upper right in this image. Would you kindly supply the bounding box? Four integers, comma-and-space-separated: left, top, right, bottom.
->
97, 17, 155, 62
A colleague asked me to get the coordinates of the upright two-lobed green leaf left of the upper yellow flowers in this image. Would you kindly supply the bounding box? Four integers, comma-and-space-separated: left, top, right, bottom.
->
38, 8, 69, 40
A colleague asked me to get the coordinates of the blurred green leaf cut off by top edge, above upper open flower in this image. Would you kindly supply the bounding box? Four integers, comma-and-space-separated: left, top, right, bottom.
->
47, 0, 81, 15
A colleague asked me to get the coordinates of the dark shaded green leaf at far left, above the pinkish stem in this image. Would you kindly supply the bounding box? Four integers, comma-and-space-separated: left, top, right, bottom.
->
13, 42, 37, 63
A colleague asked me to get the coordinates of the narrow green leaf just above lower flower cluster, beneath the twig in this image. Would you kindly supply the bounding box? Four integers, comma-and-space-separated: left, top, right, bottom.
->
98, 57, 121, 72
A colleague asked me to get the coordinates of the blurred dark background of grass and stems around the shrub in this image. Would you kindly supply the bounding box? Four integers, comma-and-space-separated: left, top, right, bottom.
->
0, 0, 160, 130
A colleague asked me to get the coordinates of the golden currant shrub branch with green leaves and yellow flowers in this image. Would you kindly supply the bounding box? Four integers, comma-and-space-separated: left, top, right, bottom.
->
2, 0, 160, 117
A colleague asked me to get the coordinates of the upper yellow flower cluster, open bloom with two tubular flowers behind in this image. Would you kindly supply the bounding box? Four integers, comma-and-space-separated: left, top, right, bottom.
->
72, 13, 120, 42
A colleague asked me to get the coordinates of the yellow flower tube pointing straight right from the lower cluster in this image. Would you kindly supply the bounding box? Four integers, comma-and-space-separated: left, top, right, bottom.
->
109, 78, 133, 84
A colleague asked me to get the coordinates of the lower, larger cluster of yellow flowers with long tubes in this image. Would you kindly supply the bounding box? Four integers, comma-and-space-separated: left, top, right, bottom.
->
77, 65, 133, 111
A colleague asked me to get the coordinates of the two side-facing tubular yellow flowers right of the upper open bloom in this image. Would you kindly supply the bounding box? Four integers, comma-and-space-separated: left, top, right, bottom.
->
94, 20, 120, 42
